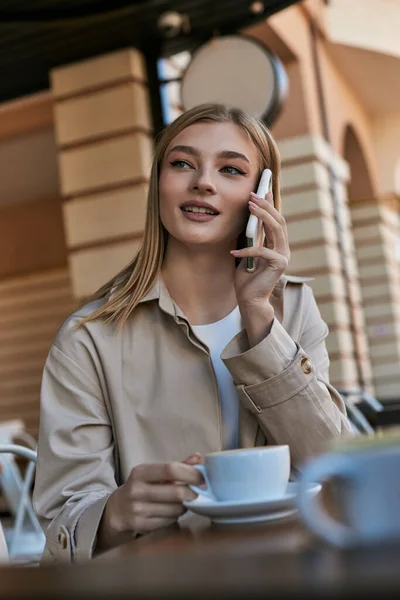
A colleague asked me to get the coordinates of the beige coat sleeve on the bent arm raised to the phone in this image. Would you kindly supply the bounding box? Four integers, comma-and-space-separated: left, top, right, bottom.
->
221, 286, 353, 469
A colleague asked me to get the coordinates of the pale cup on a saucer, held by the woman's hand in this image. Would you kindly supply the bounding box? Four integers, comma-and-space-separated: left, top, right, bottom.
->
190, 446, 290, 502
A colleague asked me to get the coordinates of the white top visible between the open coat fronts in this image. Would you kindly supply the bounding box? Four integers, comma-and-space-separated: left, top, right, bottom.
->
192, 306, 243, 449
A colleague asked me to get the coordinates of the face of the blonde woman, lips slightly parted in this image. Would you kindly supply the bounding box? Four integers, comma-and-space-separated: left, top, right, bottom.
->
159, 122, 259, 249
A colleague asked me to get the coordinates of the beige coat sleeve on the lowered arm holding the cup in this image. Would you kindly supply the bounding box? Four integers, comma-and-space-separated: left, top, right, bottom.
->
33, 324, 117, 561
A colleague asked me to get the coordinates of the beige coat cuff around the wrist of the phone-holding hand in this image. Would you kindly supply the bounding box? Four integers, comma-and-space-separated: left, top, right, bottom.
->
221, 318, 297, 386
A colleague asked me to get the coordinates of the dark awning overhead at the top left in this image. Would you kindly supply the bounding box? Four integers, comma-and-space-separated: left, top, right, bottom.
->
0, 0, 298, 102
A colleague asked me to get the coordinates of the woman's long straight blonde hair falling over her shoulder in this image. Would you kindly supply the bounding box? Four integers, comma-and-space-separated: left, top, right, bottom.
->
79, 104, 281, 328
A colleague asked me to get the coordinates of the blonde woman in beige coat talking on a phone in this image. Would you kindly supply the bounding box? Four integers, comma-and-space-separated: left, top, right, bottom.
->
34, 105, 351, 560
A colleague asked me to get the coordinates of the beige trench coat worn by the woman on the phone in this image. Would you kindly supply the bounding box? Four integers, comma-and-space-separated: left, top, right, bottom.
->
34, 276, 351, 561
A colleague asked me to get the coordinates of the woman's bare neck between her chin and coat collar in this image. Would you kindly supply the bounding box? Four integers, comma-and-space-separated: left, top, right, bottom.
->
162, 239, 237, 325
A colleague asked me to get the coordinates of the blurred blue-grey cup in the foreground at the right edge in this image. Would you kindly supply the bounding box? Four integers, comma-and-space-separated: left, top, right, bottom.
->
298, 439, 400, 547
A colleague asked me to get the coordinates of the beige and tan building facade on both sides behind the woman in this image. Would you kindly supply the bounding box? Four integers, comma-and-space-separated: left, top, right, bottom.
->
0, 0, 400, 434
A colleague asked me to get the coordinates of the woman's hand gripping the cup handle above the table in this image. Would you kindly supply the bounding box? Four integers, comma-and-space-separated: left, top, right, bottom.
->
96, 454, 204, 551
